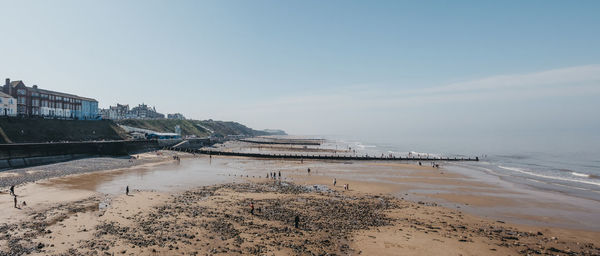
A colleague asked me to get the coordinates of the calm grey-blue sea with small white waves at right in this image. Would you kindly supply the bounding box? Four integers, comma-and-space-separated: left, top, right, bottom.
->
317, 135, 600, 202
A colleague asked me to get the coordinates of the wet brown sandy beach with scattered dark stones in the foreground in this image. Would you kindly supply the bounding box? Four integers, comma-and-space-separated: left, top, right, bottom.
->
0, 153, 600, 255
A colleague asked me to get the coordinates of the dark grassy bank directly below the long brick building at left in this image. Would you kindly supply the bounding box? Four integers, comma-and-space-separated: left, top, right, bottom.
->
0, 118, 126, 143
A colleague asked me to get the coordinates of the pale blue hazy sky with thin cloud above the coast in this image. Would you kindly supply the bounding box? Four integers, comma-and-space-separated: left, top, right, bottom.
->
0, 0, 600, 153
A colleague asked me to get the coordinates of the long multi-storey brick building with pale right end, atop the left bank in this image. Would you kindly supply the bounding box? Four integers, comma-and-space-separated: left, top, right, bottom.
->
3, 78, 98, 119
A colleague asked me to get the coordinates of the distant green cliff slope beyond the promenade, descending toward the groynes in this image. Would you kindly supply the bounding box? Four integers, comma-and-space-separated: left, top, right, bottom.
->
119, 119, 266, 137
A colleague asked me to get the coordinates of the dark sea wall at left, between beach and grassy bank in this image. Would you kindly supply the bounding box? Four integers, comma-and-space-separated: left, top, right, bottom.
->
0, 140, 165, 169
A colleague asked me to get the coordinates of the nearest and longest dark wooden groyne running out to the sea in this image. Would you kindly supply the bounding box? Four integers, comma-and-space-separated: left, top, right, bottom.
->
168, 148, 479, 161
